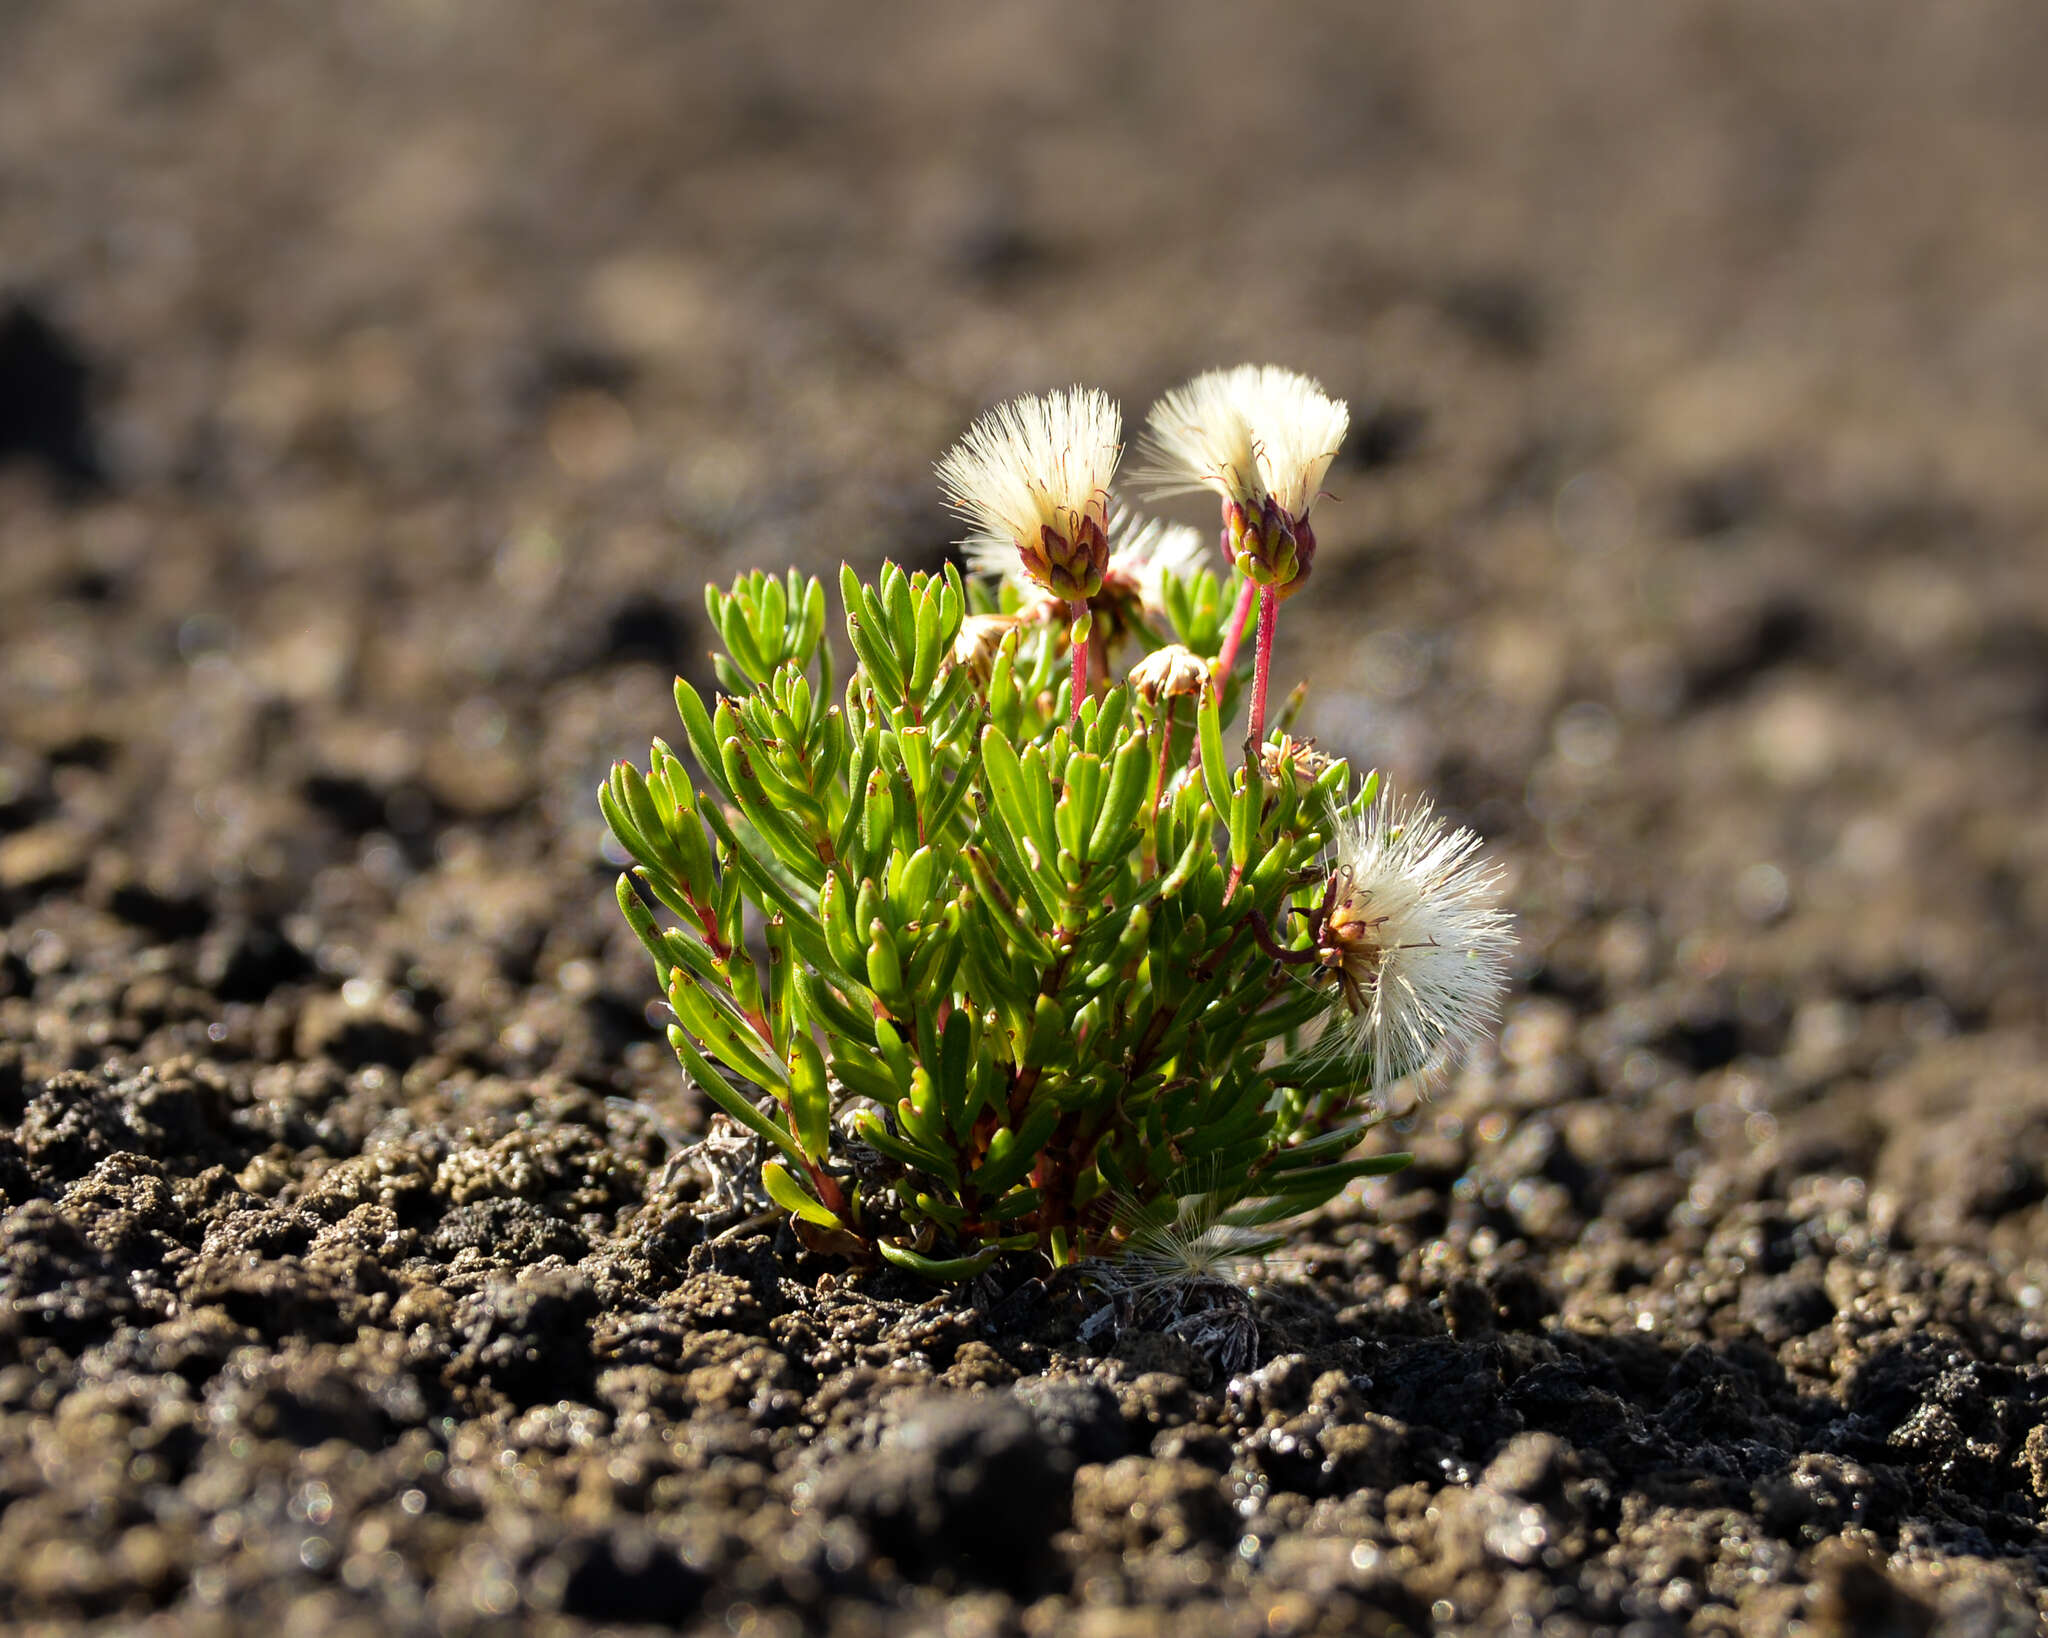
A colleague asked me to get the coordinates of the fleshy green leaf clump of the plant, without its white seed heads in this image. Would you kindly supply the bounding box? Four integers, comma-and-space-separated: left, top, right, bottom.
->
600, 565, 1407, 1280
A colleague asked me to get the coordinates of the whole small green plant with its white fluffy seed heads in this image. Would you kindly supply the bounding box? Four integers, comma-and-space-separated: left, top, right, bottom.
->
600, 371, 1509, 1280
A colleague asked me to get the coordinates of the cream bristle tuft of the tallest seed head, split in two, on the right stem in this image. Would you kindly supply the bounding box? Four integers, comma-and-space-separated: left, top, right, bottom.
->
1141, 364, 1352, 522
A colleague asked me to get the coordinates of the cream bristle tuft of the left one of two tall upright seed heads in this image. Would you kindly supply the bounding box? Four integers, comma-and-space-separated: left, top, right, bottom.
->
938, 387, 1122, 573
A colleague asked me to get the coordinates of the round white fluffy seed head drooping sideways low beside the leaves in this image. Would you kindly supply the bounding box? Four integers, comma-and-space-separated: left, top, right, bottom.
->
1323, 796, 1513, 1091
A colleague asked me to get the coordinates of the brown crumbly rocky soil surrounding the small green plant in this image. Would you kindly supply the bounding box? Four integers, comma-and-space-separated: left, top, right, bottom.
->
0, 0, 2048, 1638
